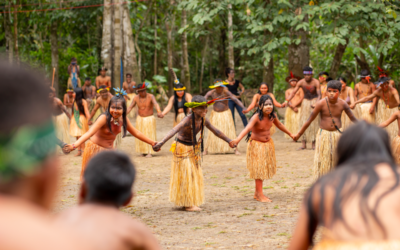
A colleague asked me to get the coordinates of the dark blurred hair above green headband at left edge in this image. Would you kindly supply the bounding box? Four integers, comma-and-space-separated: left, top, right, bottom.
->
0, 60, 51, 135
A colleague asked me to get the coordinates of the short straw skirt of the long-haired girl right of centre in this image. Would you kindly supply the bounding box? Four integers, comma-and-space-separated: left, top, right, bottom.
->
246, 139, 276, 180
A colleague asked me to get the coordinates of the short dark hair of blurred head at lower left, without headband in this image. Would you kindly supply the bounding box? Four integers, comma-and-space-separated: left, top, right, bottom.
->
83, 151, 136, 207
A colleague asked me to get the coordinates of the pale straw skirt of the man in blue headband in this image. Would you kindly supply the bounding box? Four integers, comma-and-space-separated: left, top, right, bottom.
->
299, 98, 320, 142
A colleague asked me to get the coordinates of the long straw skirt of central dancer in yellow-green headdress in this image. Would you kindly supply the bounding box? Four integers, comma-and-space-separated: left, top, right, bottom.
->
169, 143, 204, 207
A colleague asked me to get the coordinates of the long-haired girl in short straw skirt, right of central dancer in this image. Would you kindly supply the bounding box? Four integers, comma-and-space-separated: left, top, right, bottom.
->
229, 95, 294, 202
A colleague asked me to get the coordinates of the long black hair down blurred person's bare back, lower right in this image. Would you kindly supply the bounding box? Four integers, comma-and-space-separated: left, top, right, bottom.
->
306, 121, 400, 243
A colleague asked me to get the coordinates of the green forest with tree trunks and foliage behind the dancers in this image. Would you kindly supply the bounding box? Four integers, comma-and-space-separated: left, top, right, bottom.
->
0, 0, 400, 101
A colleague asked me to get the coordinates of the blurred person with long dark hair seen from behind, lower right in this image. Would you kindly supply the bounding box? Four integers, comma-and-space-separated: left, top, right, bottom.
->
289, 121, 400, 250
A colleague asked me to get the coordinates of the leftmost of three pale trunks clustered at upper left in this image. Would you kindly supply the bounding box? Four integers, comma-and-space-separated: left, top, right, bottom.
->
101, 0, 113, 76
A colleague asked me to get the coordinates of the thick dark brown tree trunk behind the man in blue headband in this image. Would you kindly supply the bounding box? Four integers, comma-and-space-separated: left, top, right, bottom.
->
288, 17, 310, 77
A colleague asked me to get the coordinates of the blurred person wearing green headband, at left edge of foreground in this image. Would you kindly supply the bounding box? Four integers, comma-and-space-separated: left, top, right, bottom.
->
0, 61, 89, 250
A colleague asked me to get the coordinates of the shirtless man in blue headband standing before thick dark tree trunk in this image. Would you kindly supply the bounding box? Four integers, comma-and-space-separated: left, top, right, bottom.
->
284, 66, 321, 150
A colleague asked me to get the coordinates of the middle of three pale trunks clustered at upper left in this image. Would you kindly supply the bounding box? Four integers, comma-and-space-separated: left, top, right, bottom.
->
112, 0, 122, 88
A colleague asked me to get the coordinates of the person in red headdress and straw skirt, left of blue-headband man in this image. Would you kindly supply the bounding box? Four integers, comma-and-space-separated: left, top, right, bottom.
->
285, 71, 304, 139
